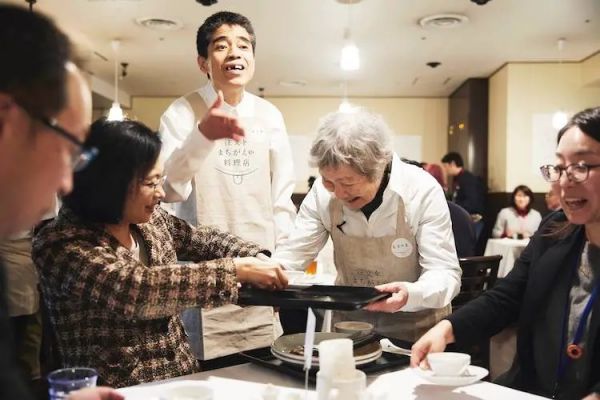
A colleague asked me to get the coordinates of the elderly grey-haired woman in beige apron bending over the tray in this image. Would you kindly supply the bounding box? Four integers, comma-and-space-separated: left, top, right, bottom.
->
273, 111, 461, 342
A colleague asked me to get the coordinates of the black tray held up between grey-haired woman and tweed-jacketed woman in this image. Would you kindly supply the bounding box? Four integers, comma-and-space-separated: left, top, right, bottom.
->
238, 285, 391, 311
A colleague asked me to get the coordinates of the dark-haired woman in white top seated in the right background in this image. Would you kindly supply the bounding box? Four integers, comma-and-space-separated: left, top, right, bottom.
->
492, 185, 542, 239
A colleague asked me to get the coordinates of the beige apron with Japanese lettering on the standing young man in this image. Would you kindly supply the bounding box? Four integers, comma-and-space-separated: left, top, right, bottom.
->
179, 92, 282, 360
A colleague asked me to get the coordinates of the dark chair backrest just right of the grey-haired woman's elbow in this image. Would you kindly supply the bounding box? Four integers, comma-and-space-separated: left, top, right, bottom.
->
452, 255, 502, 311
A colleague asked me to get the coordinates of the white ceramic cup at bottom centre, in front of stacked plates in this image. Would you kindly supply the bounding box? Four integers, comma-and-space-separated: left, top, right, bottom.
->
317, 369, 367, 400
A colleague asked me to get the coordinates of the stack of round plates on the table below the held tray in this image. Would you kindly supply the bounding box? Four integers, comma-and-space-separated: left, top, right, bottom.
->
271, 332, 381, 366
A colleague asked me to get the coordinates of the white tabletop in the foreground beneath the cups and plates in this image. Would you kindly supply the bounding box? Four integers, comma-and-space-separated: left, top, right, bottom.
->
120, 364, 542, 400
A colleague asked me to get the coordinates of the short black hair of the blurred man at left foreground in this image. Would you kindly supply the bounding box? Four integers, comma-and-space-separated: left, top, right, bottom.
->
0, 5, 71, 117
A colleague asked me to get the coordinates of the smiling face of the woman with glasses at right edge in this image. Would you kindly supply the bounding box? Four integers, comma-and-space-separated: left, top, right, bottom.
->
552, 126, 600, 225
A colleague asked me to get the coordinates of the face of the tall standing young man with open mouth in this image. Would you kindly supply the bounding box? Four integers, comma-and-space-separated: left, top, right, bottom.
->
198, 25, 254, 92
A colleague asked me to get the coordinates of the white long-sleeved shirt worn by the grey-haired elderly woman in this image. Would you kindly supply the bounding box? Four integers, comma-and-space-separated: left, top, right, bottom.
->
273, 154, 461, 311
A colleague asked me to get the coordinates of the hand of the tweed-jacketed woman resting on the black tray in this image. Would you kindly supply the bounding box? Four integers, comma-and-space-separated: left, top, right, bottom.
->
233, 257, 288, 290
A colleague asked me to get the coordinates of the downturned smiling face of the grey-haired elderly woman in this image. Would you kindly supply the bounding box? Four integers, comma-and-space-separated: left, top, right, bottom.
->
319, 165, 381, 210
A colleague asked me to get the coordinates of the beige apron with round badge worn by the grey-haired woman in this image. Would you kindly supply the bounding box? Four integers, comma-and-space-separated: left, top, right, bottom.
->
329, 198, 450, 342
